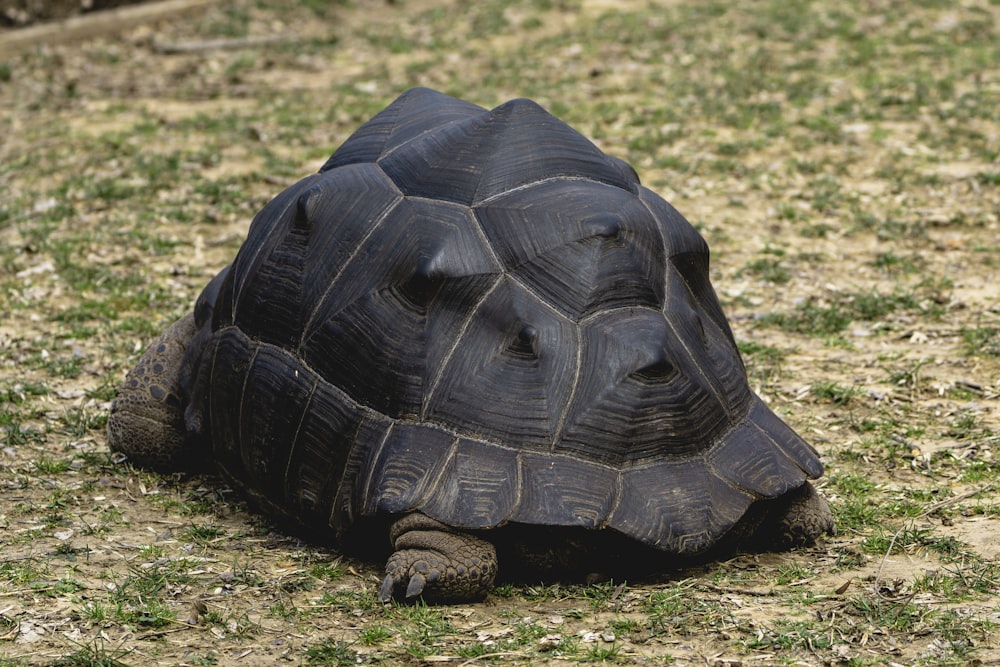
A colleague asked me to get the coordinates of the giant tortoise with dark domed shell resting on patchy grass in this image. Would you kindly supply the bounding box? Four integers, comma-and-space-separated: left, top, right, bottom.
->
108, 88, 834, 602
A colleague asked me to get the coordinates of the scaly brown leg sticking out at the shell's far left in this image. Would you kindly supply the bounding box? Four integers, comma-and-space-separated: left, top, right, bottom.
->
108, 314, 196, 470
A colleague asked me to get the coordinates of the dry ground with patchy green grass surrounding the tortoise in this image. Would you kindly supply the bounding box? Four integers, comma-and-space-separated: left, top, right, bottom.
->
0, 0, 1000, 665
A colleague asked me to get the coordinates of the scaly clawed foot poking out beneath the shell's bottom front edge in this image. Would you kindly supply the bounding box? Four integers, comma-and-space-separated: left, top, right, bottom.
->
379, 513, 497, 602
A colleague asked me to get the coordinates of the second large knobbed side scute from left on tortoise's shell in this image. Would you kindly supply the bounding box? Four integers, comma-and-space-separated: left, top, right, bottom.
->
300, 200, 497, 417
